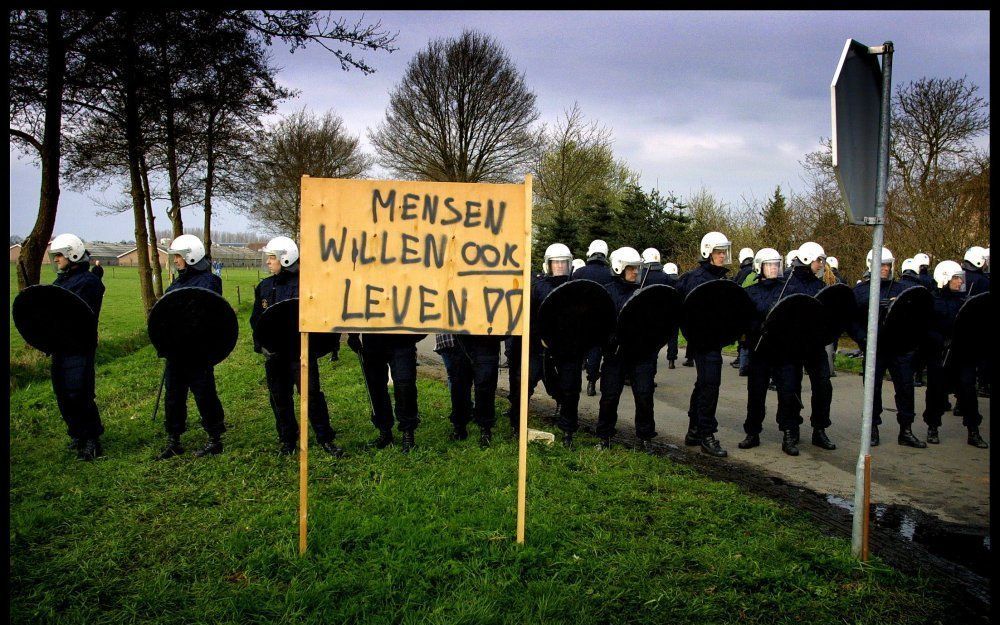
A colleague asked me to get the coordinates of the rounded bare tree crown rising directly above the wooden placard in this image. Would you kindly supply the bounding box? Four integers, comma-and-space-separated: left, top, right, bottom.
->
369, 31, 538, 182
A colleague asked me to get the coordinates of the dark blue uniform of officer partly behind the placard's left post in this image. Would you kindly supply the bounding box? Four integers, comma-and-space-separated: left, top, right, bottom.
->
250, 263, 335, 446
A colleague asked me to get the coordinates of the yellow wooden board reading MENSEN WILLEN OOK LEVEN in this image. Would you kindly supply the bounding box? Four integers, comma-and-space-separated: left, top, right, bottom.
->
299, 177, 526, 334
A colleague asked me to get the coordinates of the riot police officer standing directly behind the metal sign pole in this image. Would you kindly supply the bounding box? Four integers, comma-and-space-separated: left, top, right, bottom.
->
848, 247, 927, 449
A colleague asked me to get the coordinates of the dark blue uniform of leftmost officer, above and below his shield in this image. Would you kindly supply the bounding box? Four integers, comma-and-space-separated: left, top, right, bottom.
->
51, 262, 104, 442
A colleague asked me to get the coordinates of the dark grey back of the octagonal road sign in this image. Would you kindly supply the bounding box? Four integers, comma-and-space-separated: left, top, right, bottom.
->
830, 39, 882, 225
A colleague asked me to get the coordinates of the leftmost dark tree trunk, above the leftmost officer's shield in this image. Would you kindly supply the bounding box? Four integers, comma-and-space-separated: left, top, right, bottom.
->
17, 9, 66, 291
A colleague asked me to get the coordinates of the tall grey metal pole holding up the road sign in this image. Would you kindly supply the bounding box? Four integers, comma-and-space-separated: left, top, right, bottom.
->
851, 41, 893, 560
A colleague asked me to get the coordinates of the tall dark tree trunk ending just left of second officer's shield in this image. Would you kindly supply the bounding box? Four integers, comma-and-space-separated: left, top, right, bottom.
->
125, 11, 156, 317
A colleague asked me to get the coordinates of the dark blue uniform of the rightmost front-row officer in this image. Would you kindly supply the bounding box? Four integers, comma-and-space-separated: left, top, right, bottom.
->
923, 285, 983, 428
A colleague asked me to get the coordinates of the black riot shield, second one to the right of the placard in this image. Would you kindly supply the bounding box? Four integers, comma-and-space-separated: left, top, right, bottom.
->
615, 284, 681, 358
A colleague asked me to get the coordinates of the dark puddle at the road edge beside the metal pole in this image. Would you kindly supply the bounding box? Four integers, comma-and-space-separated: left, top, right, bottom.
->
826, 495, 992, 578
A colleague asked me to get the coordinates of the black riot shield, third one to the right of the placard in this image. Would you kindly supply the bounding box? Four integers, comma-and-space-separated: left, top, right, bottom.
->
681, 280, 757, 349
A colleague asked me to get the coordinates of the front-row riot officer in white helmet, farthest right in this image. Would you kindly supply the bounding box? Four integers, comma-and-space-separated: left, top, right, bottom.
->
923, 260, 989, 449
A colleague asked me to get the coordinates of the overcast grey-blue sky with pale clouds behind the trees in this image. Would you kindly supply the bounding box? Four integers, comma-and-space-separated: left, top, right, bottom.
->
10, 11, 990, 241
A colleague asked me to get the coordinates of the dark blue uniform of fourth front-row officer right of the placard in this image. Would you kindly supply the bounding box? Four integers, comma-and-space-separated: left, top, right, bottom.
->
743, 276, 802, 434
